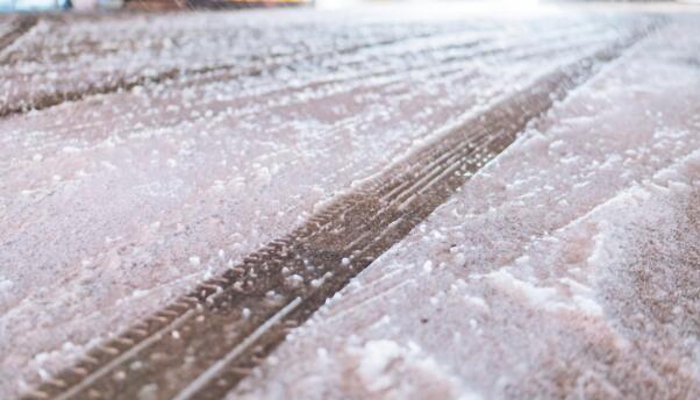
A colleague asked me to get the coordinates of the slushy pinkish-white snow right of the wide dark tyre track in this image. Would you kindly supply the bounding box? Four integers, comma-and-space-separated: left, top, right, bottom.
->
230, 20, 700, 399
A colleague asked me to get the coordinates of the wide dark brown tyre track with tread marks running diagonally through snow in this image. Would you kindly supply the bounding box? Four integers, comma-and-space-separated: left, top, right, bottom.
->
17, 21, 660, 400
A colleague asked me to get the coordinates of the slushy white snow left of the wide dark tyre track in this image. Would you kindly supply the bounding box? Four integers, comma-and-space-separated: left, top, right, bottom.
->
0, 7, 660, 398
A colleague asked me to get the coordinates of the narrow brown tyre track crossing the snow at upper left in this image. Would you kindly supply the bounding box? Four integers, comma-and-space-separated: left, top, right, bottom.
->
0, 17, 628, 118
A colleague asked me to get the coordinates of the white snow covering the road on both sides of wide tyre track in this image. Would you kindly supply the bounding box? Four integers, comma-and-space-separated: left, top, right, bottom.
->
0, 3, 700, 398
